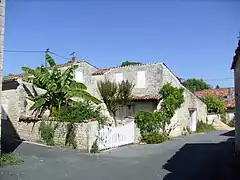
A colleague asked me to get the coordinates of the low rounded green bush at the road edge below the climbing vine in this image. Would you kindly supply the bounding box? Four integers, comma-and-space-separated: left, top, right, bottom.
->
141, 132, 169, 144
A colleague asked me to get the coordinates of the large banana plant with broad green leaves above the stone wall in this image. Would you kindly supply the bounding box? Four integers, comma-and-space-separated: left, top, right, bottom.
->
22, 54, 101, 114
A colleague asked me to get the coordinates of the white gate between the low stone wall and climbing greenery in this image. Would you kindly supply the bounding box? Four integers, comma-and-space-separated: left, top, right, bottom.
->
98, 121, 134, 150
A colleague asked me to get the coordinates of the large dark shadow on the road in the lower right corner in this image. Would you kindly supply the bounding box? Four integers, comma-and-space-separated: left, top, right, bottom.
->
163, 138, 240, 180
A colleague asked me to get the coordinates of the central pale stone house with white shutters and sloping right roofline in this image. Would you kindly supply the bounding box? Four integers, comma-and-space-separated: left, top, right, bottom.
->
2, 58, 207, 136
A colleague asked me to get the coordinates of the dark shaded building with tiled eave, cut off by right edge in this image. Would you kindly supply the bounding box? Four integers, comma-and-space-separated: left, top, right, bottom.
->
231, 40, 240, 152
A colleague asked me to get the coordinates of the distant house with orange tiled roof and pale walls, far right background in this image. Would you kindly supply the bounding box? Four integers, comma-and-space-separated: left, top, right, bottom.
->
194, 87, 235, 121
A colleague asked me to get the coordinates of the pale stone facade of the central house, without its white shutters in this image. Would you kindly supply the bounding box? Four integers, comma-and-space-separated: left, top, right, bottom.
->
72, 62, 207, 136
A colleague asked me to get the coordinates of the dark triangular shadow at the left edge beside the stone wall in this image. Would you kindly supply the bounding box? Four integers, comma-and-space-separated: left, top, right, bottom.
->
1, 108, 22, 153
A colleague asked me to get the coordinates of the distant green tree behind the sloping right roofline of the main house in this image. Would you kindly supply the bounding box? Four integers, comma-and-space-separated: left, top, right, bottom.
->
183, 78, 212, 92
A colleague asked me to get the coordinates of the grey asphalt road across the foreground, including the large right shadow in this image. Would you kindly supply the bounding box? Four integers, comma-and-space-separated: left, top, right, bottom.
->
0, 132, 239, 180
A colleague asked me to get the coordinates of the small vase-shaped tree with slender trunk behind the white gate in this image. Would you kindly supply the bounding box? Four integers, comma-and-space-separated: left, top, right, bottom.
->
97, 80, 134, 126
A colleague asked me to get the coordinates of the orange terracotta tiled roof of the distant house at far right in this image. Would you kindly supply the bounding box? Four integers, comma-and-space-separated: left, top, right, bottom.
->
194, 88, 235, 109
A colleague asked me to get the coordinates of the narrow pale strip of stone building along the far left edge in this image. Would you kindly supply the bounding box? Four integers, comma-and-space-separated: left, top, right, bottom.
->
0, 0, 6, 132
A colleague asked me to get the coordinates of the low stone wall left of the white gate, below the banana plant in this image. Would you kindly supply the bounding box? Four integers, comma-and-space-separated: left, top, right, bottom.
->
2, 119, 98, 151
